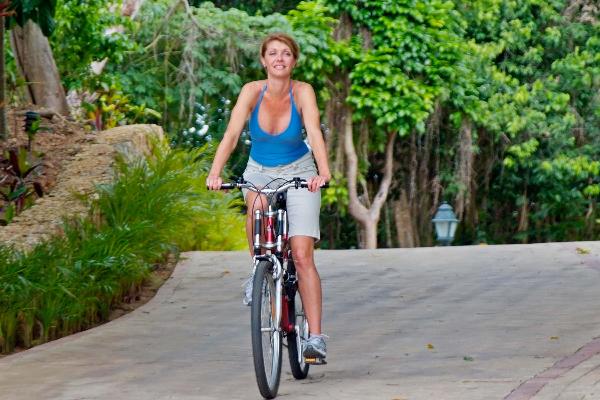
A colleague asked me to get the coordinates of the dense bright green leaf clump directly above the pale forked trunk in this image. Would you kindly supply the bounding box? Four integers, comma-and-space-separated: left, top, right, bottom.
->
338, 1, 462, 135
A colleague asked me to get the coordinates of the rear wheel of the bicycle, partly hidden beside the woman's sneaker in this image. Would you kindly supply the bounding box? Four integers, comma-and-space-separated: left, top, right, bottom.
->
287, 284, 310, 379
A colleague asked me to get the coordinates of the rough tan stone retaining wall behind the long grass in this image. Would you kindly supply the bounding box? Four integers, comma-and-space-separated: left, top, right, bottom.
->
0, 120, 163, 250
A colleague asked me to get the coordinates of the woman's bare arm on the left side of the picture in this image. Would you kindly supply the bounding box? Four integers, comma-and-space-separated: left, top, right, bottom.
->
206, 82, 256, 190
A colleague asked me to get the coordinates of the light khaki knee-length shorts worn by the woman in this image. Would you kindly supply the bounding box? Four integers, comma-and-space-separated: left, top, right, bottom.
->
243, 152, 321, 240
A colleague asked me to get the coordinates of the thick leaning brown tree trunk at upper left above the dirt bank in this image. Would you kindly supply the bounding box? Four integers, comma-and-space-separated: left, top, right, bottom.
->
11, 20, 69, 115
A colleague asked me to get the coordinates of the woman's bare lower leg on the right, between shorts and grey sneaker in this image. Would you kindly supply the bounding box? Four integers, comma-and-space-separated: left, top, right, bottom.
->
290, 236, 322, 335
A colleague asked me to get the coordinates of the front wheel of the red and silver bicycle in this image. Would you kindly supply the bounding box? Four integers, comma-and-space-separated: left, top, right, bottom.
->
251, 261, 281, 399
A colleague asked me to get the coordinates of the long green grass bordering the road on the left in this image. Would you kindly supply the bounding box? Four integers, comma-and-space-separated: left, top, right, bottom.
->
0, 144, 245, 353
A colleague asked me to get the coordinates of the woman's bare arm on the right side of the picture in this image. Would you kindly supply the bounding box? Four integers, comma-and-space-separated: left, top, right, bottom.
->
297, 82, 331, 192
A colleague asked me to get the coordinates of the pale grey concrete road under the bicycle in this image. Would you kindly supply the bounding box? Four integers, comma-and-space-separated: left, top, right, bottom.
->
0, 242, 600, 400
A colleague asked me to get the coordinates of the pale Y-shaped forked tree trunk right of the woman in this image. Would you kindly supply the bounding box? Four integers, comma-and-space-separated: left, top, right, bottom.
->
343, 107, 398, 249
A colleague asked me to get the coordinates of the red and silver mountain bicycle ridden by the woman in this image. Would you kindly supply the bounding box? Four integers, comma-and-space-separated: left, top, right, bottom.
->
221, 178, 325, 399
